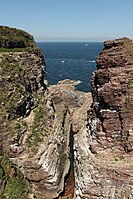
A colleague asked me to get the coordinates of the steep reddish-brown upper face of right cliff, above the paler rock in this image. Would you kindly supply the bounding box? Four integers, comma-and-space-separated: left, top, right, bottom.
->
90, 38, 133, 153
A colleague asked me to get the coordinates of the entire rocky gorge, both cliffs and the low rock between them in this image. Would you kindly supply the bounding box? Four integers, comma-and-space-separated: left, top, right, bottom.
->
0, 26, 133, 199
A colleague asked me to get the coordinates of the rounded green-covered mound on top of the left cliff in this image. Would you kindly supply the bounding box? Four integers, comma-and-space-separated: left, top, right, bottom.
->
0, 26, 40, 53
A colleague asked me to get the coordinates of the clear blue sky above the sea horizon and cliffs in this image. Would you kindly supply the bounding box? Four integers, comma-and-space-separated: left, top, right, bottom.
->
0, 0, 133, 41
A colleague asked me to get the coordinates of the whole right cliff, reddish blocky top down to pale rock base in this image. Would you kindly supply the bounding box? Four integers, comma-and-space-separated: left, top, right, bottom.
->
75, 38, 133, 199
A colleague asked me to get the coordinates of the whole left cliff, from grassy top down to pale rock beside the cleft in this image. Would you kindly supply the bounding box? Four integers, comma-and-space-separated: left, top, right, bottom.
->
0, 27, 71, 199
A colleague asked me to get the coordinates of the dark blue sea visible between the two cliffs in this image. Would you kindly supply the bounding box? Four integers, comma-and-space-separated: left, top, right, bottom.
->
37, 42, 103, 92
